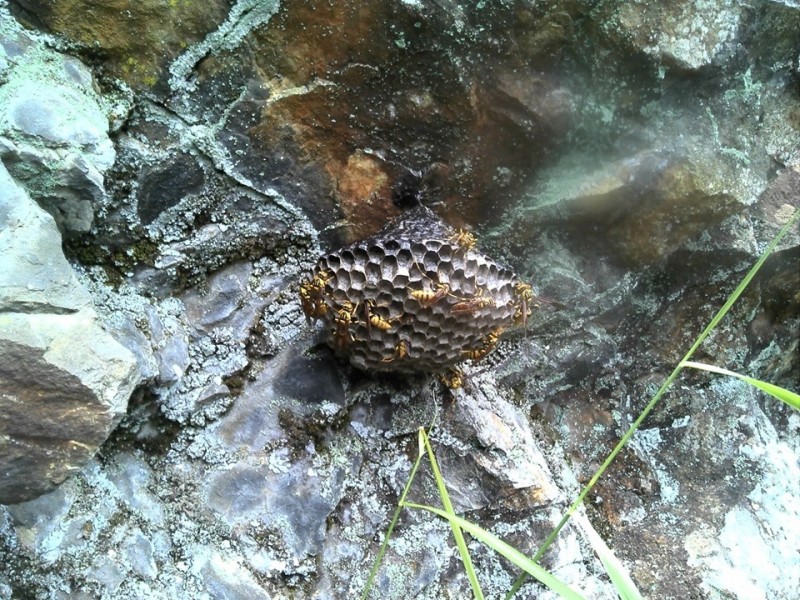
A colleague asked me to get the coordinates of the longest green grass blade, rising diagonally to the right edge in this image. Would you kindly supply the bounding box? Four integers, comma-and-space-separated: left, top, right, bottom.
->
506, 210, 800, 600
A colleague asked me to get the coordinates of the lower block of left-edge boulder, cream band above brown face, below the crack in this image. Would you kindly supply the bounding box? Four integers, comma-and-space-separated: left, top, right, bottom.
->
0, 309, 139, 503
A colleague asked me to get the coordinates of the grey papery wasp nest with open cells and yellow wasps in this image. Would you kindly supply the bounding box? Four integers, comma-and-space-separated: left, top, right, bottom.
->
300, 206, 533, 373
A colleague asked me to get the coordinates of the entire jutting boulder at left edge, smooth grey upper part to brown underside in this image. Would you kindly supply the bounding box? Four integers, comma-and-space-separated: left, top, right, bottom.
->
0, 165, 139, 504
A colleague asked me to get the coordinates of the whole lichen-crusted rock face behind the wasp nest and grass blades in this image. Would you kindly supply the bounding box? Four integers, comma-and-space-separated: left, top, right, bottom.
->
0, 0, 800, 599
